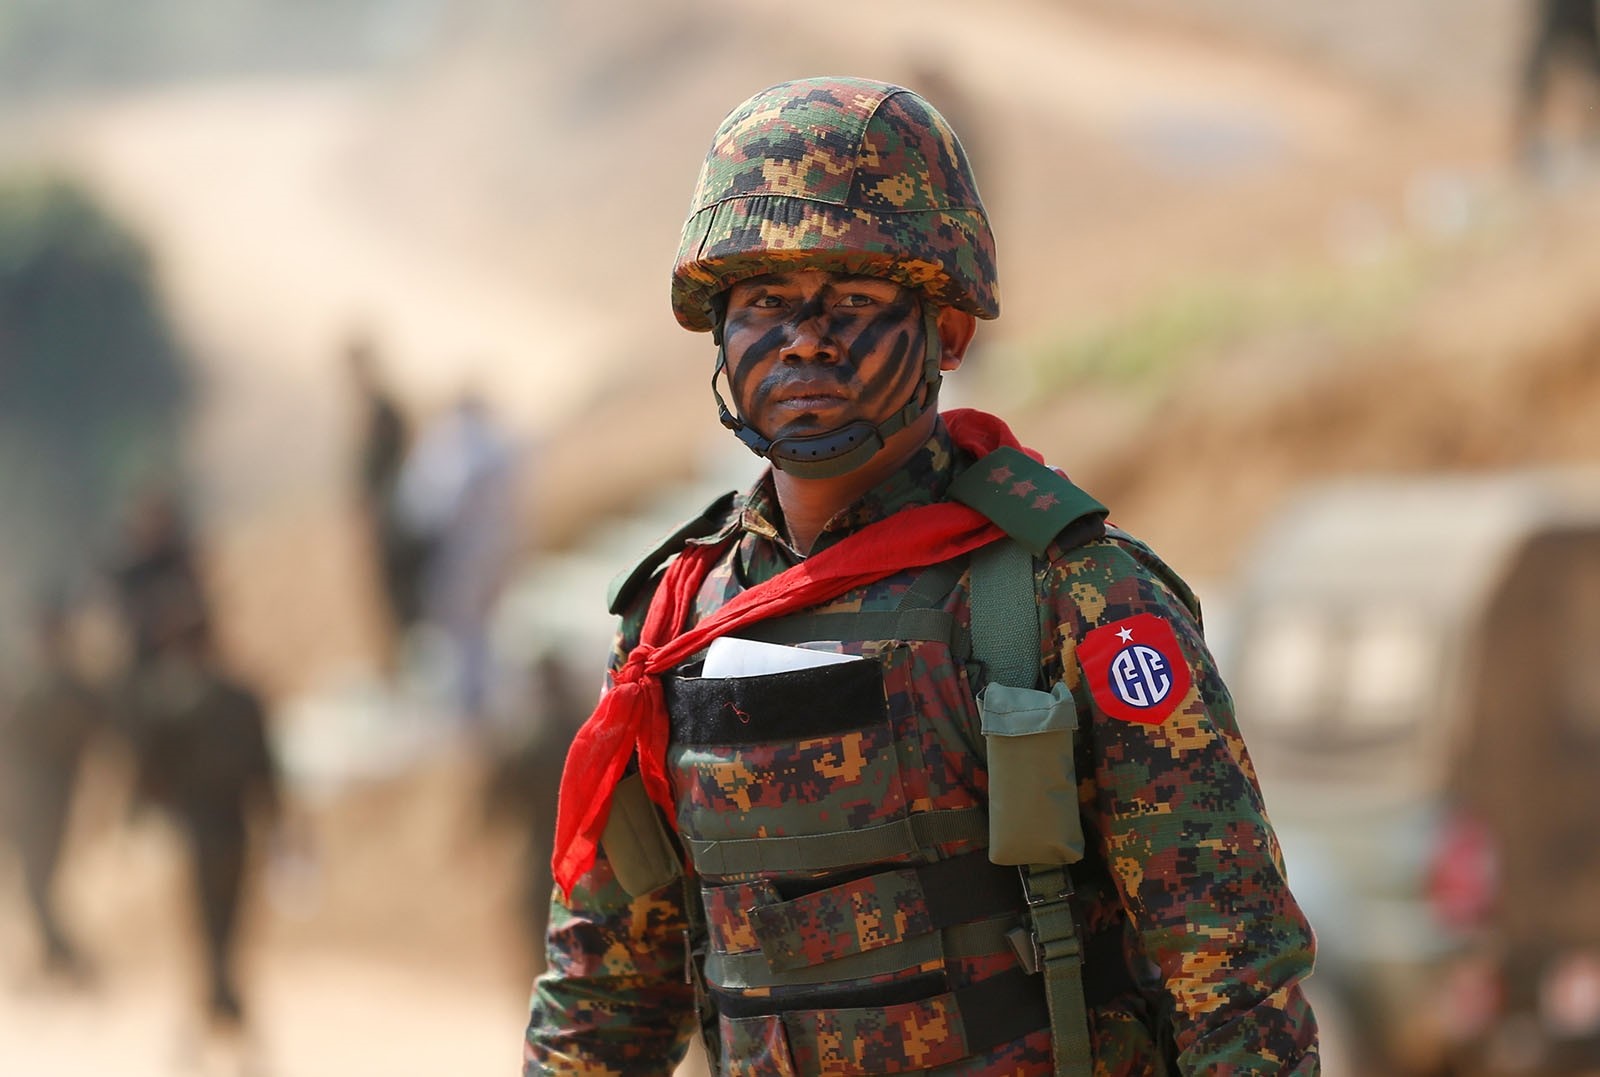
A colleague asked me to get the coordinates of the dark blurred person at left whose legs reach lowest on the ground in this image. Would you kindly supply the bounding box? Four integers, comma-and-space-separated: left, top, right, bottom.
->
123, 604, 282, 1027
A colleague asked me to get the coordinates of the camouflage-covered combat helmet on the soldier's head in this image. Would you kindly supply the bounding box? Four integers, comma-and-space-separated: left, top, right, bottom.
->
672, 77, 1000, 331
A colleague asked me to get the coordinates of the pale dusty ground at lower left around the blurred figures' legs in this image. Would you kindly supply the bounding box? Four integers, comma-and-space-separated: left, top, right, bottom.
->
0, 739, 531, 1077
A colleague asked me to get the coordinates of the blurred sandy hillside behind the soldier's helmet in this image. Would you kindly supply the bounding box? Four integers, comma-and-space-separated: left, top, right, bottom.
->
8, 0, 1594, 694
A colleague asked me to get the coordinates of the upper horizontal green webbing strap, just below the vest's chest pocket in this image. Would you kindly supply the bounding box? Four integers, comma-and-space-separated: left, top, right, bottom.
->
688, 808, 989, 877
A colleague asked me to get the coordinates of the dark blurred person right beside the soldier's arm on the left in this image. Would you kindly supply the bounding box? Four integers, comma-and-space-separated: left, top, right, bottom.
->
483, 645, 595, 971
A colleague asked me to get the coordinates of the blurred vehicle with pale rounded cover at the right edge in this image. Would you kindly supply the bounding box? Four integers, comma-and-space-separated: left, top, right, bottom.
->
1218, 470, 1600, 1077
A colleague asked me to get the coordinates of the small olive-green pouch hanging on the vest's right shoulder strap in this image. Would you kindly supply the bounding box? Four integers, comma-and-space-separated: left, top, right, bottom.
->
978, 683, 1083, 864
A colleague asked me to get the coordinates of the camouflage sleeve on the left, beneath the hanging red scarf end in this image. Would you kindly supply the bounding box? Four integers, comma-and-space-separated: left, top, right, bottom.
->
523, 608, 694, 1077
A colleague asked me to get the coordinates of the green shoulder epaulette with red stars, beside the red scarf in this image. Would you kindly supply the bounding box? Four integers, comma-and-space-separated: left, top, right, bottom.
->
950, 446, 1107, 557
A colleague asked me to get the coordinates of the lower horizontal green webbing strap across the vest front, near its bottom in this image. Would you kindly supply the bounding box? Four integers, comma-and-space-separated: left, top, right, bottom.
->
706, 914, 1018, 991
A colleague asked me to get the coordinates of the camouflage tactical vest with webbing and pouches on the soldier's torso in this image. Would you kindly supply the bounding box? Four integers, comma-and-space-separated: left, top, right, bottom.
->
603, 450, 1106, 1075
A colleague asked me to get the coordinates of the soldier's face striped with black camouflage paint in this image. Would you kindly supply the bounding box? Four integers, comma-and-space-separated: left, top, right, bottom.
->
723, 269, 926, 440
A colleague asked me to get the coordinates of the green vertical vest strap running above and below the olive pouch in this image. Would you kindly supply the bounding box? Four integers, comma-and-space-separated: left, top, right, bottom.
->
971, 539, 1094, 1077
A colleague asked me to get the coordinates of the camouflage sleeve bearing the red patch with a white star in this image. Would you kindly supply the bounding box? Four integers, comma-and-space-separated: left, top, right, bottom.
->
1046, 538, 1318, 1075
